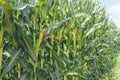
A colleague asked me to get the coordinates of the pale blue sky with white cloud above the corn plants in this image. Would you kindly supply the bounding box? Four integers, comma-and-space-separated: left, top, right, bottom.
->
100, 0, 120, 27
